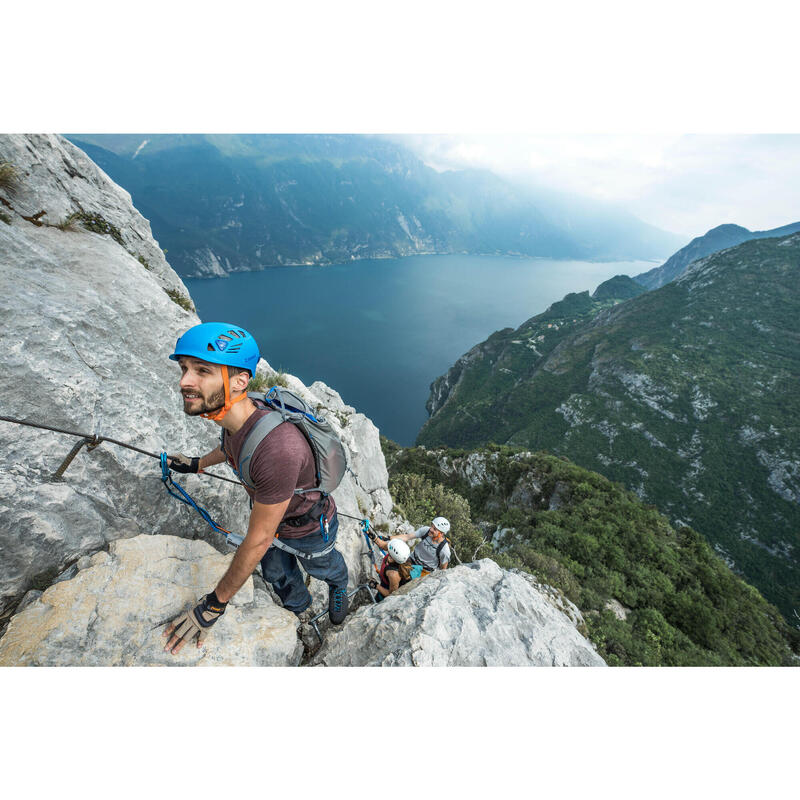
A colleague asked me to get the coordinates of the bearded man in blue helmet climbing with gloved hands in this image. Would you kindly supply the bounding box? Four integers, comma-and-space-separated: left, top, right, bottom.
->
164, 322, 348, 654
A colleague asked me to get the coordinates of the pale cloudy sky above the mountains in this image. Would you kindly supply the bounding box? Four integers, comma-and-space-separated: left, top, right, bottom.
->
398, 134, 800, 237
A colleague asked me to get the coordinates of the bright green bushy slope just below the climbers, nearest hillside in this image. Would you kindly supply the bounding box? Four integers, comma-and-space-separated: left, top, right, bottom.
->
383, 440, 800, 666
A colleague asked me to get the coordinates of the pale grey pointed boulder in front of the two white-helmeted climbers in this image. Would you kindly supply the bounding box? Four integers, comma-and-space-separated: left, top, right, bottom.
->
312, 559, 605, 667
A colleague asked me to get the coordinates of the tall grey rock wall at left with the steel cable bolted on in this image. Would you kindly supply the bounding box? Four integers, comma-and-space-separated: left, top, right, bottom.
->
0, 136, 247, 618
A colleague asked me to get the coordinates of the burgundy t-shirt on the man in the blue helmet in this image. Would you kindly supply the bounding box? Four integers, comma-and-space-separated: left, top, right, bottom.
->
224, 409, 336, 539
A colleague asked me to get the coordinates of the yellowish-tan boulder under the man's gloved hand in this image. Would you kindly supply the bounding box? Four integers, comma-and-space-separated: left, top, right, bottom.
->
0, 536, 303, 667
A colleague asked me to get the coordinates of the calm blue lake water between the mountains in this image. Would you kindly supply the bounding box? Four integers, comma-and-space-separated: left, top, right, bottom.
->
185, 255, 657, 446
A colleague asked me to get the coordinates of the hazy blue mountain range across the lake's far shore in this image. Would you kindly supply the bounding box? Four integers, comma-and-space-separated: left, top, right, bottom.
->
64, 135, 679, 276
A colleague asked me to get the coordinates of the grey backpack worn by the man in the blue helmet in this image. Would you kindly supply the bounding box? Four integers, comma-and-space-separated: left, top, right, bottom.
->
221, 386, 347, 495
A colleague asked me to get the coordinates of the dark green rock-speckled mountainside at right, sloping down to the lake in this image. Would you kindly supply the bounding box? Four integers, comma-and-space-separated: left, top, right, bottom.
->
418, 234, 800, 622
